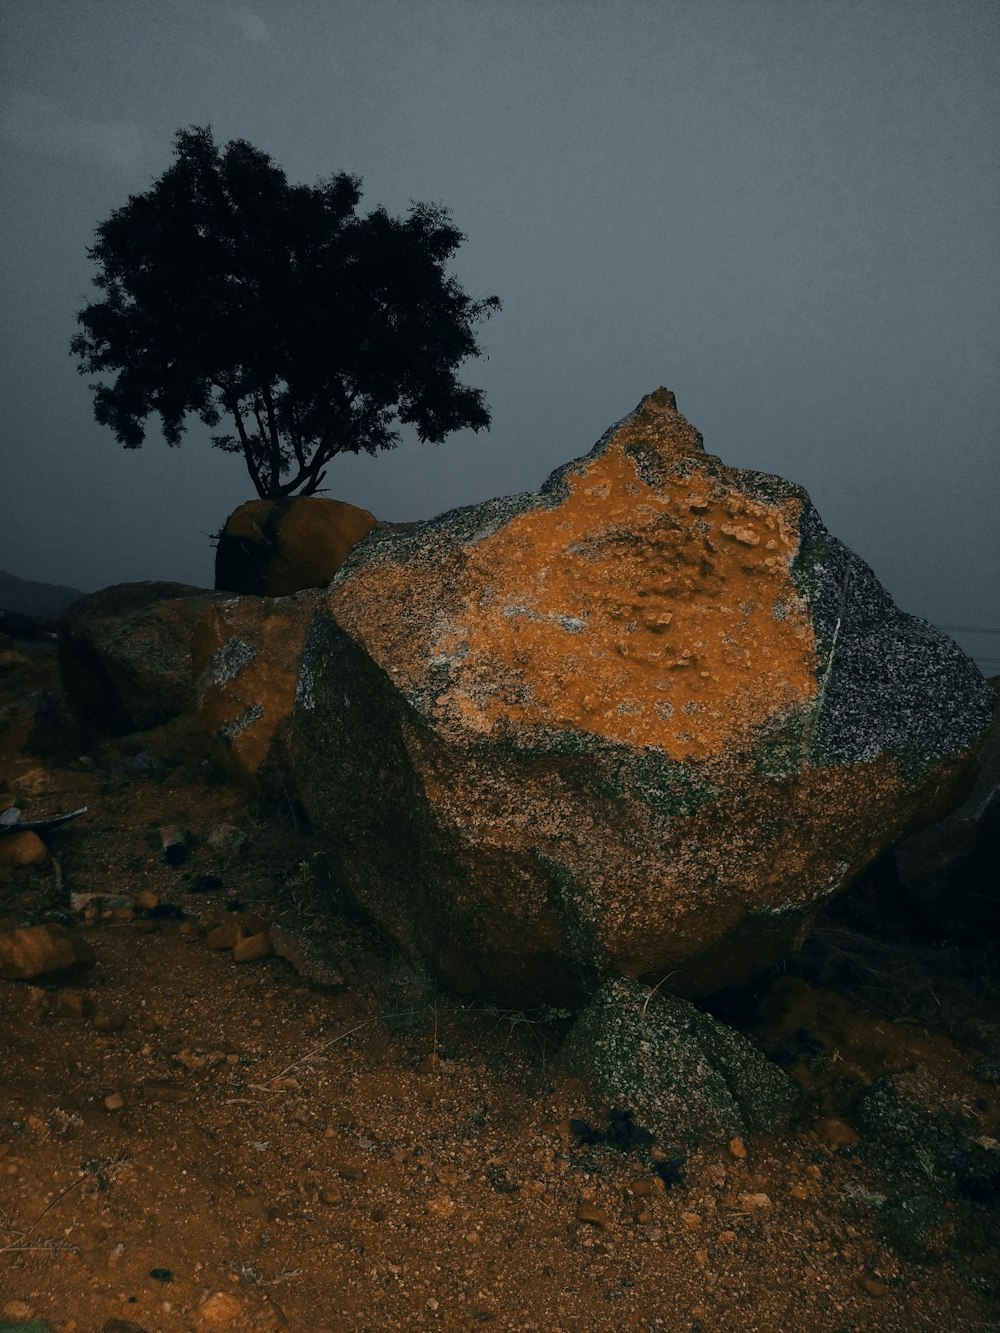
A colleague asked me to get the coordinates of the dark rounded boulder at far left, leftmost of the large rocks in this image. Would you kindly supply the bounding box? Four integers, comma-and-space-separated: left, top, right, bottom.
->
59, 583, 221, 732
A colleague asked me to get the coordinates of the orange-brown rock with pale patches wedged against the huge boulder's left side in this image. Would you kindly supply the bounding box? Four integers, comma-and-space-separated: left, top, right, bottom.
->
192, 592, 317, 786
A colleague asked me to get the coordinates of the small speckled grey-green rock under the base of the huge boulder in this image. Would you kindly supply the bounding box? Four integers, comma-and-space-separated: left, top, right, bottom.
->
559, 977, 797, 1153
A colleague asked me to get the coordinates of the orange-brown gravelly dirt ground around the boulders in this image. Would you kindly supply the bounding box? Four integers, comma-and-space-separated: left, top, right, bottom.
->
0, 645, 1000, 1333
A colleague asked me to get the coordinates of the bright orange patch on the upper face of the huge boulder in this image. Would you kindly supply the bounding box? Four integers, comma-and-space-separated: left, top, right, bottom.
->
331, 391, 816, 760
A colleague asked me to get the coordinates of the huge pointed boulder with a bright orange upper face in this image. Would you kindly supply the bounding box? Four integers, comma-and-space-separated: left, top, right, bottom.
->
293, 389, 993, 1005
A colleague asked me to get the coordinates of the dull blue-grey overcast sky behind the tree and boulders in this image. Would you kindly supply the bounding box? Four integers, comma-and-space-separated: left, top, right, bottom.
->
0, 0, 1000, 672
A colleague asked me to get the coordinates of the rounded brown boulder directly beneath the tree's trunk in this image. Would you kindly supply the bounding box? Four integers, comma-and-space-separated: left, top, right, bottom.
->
215, 496, 376, 597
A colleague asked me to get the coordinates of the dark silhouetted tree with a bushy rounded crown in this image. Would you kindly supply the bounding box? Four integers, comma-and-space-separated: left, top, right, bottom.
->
71, 127, 500, 499
